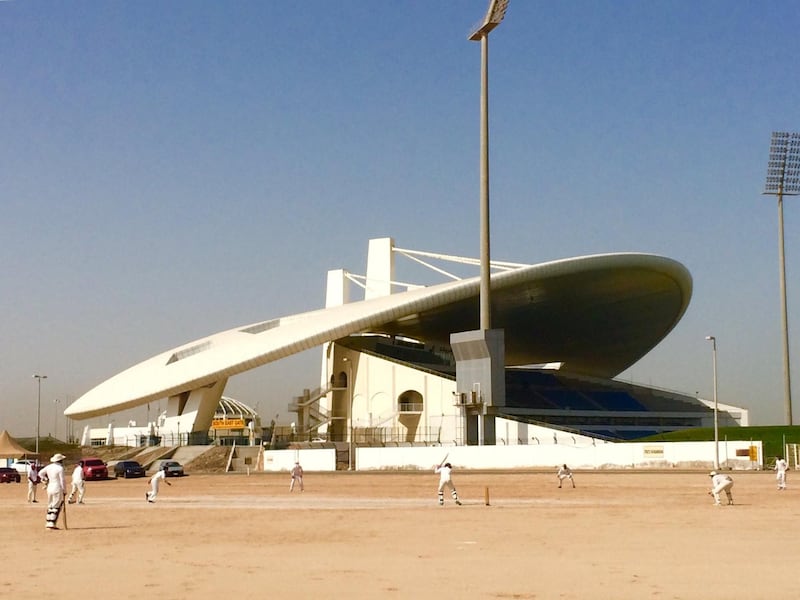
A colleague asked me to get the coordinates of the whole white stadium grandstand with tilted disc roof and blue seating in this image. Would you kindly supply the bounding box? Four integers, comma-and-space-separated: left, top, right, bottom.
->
65, 238, 748, 447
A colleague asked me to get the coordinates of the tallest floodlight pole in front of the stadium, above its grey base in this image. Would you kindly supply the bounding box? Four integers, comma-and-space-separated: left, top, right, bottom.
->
469, 0, 508, 331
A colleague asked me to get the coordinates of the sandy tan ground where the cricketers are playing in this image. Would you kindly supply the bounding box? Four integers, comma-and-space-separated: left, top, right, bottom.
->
0, 471, 800, 600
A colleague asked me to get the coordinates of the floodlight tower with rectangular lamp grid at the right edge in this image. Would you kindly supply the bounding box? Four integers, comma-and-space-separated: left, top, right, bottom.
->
764, 131, 800, 425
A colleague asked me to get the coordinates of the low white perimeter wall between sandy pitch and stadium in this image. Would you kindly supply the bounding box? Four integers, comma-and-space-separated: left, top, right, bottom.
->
262, 441, 764, 471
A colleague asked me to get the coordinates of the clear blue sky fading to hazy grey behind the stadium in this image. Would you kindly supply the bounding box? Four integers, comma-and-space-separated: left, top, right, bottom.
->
0, 0, 800, 436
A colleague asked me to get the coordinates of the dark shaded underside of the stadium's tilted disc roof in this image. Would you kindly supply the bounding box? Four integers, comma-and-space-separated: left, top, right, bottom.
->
372, 267, 687, 377
